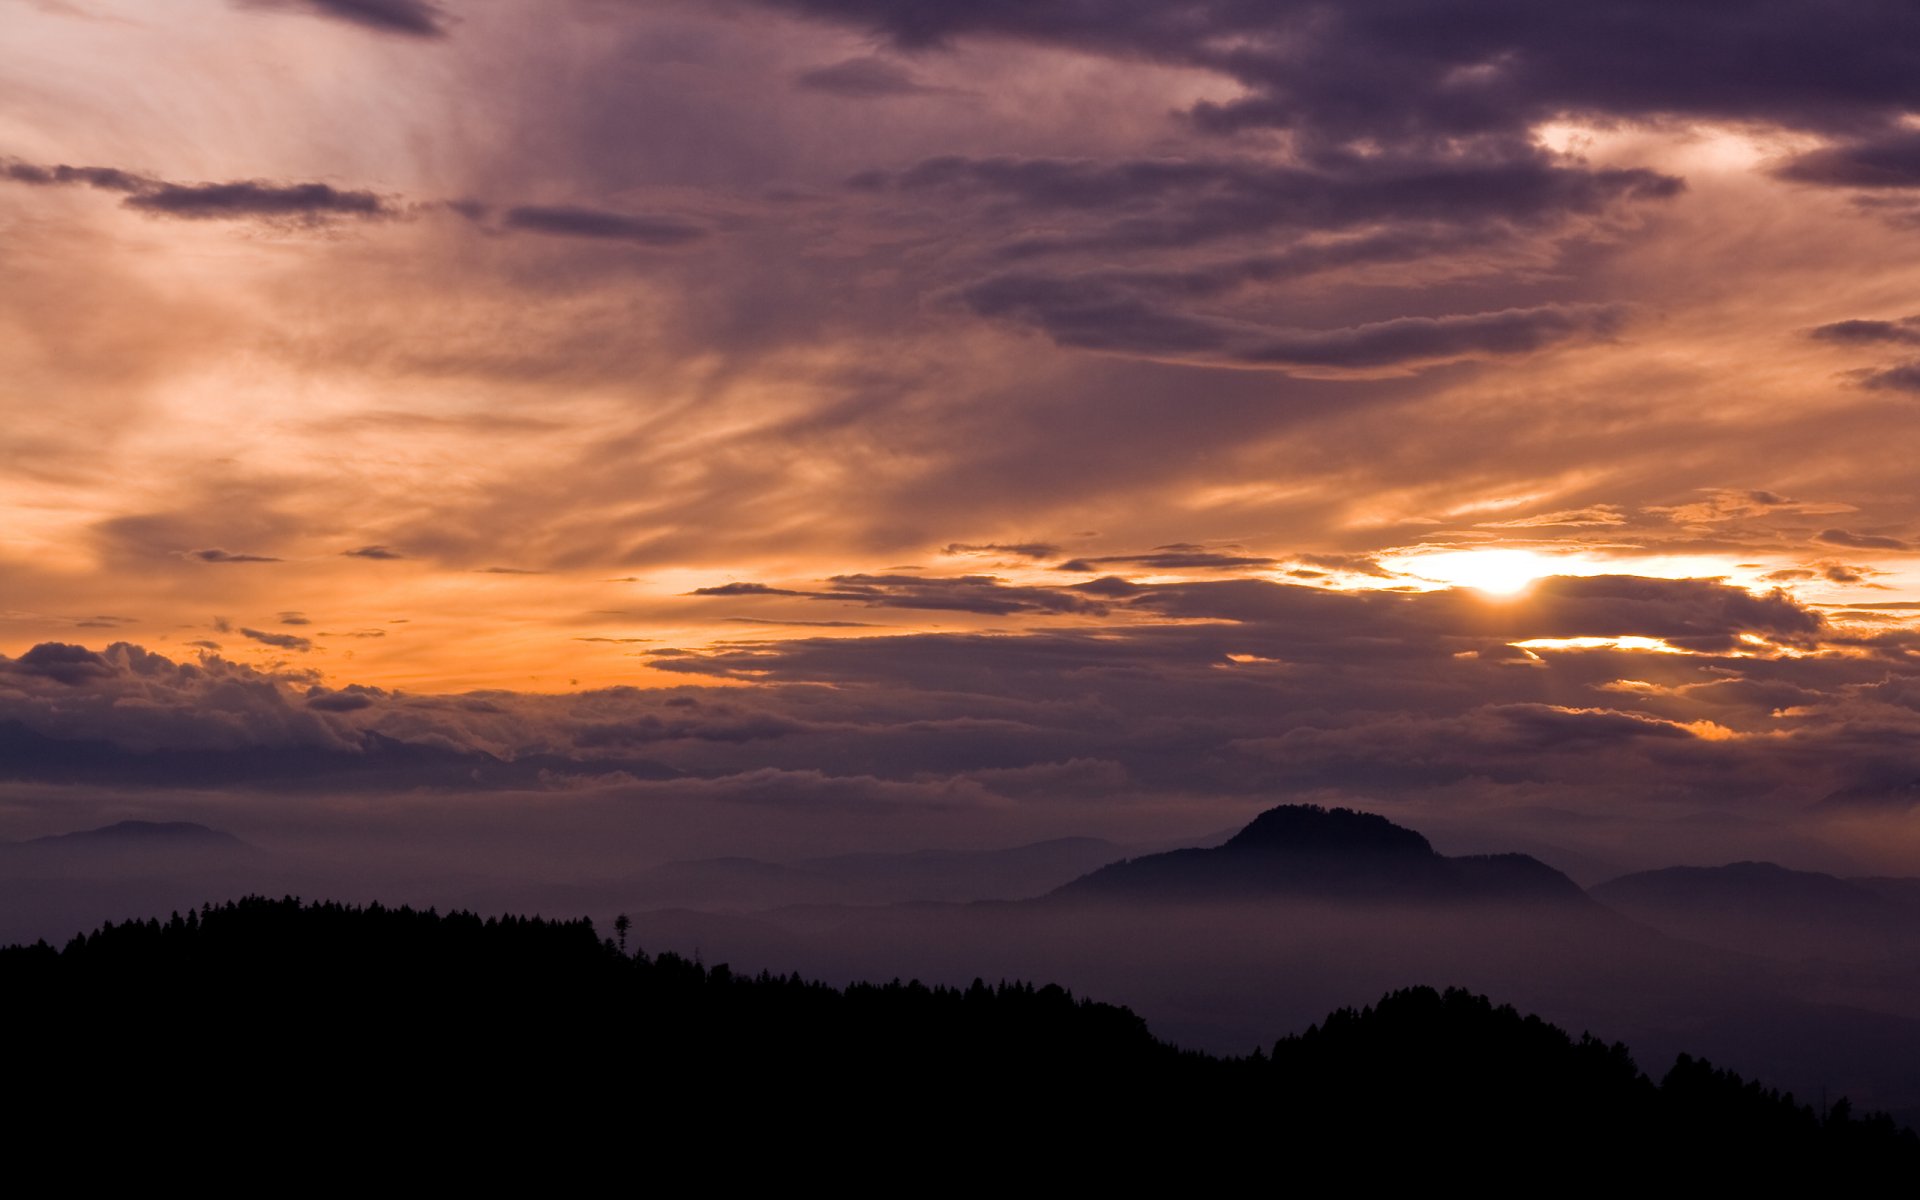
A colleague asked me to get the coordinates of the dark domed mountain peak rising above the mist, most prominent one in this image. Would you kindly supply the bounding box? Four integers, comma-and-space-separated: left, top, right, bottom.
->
1052, 804, 1592, 906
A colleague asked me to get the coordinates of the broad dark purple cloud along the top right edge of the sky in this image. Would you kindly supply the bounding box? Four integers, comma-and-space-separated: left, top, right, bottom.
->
762, 0, 1920, 148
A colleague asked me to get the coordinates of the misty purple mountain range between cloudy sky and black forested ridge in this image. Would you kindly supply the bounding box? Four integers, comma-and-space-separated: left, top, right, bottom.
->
0, 804, 1920, 1119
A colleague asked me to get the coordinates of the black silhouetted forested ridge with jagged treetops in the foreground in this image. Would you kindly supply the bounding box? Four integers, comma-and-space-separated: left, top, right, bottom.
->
0, 899, 1920, 1181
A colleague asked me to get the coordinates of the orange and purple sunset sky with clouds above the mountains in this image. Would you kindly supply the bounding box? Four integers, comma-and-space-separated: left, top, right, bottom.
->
0, 0, 1920, 874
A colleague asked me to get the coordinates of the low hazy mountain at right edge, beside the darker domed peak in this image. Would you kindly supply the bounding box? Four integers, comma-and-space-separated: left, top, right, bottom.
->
1594, 862, 1920, 958
